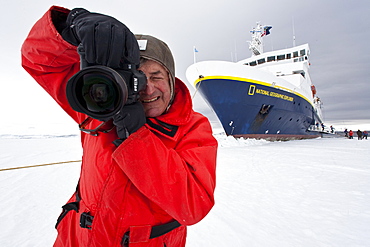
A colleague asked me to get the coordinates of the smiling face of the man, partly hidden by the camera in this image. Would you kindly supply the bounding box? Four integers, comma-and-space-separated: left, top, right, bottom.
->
138, 60, 171, 117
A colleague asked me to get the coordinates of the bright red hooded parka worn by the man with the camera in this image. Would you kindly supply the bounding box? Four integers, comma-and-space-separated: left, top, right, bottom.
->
22, 6, 217, 247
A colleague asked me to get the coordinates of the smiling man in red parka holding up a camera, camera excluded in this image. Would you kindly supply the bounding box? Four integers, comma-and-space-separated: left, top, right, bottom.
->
22, 6, 217, 247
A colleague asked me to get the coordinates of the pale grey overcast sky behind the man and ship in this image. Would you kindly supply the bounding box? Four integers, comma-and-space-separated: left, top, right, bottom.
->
0, 0, 370, 130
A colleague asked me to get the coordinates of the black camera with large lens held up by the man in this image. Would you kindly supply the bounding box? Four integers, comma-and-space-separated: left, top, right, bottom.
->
66, 45, 147, 121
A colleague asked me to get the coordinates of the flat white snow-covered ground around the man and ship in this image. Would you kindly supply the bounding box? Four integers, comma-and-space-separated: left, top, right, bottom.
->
0, 125, 370, 247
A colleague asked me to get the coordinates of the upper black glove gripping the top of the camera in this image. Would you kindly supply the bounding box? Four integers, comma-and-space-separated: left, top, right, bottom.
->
56, 8, 140, 68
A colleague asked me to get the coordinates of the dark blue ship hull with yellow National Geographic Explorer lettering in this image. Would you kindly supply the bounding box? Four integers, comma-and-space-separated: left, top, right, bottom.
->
196, 77, 320, 140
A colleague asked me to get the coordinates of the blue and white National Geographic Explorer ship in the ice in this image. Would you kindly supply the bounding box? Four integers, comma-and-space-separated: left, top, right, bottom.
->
186, 23, 322, 140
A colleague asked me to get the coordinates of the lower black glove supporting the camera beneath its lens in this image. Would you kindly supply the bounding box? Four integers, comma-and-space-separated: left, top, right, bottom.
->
113, 102, 146, 146
